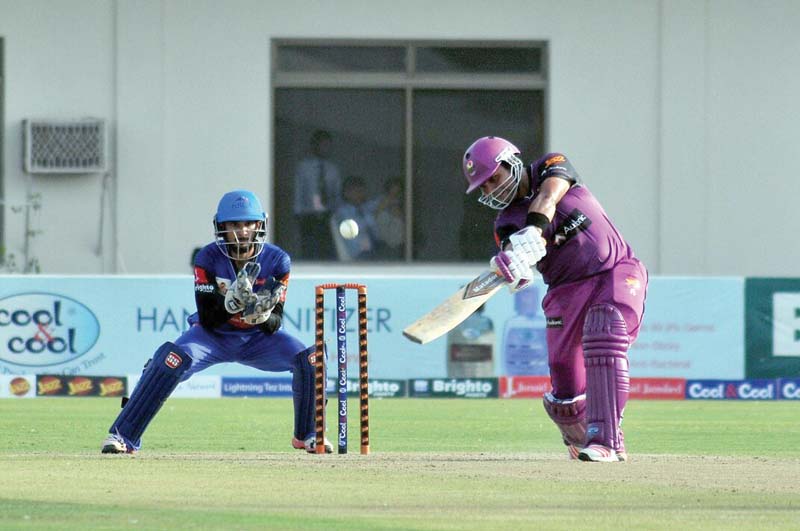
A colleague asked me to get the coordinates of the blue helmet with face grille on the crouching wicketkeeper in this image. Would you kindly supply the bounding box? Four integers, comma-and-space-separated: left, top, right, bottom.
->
214, 190, 267, 260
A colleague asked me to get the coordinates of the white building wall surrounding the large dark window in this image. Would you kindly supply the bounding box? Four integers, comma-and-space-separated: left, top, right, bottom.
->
0, 0, 800, 275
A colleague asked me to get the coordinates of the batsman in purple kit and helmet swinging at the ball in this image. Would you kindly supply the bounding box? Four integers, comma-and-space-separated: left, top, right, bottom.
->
462, 136, 647, 462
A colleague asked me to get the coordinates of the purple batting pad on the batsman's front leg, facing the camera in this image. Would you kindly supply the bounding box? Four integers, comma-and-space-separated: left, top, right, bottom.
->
583, 304, 630, 450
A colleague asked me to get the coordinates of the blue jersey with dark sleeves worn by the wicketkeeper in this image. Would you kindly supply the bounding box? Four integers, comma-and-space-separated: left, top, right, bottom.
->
189, 243, 291, 333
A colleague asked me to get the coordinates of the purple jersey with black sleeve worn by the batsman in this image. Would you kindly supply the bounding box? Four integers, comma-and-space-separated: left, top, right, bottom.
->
495, 153, 634, 287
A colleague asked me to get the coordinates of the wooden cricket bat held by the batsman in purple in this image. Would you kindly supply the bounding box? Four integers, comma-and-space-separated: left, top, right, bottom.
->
403, 269, 506, 345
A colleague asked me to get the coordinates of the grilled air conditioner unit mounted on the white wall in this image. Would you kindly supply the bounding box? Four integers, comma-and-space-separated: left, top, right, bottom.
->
22, 118, 108, 174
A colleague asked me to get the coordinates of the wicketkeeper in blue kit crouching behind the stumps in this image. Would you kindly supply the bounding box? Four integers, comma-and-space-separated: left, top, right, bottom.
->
102, 190, 333, 454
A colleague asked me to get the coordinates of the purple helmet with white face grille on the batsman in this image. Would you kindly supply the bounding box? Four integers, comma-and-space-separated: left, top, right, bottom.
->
461, 136, 523, 210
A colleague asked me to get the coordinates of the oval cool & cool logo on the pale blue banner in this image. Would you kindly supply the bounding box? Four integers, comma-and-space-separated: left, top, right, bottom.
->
0, 293, 100, 367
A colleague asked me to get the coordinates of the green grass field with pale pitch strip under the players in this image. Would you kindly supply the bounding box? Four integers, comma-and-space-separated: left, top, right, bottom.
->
0, 398, 800, 530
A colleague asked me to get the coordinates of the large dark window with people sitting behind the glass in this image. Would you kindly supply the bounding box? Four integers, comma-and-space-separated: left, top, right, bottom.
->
271, 40, 547, 263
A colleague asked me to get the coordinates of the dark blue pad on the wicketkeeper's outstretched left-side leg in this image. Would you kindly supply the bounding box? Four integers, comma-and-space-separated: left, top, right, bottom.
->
108, 342, 192, 449
